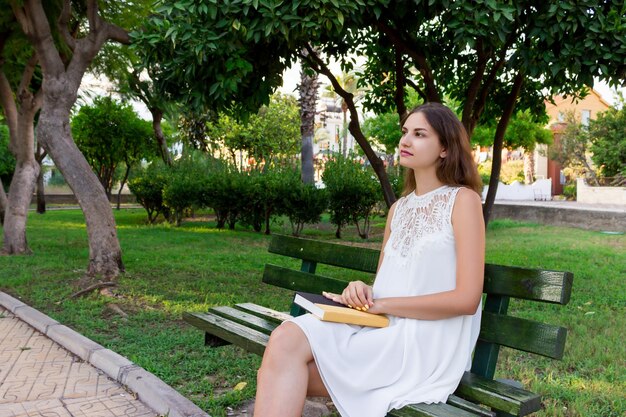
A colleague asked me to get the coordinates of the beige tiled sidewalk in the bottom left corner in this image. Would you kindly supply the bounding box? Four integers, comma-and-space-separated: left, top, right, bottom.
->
0, 307, 157, 417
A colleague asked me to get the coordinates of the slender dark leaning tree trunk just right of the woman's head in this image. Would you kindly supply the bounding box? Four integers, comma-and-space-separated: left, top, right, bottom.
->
483, 73, 524, 227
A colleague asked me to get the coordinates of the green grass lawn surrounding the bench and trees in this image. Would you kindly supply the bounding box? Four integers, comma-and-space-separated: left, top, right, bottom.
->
0, 210, 626, 417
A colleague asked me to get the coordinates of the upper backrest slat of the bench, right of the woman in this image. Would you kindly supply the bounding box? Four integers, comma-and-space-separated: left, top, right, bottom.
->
484, 264, 574, 305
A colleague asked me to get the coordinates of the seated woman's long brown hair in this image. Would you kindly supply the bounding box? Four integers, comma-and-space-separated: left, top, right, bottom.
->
402, 103, 483, 196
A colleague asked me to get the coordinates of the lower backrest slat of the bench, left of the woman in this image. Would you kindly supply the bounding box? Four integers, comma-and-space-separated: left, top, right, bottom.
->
263, 264, 348, 293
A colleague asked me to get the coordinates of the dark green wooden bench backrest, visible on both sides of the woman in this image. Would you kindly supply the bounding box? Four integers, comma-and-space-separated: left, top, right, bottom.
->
263, 235, 573, 378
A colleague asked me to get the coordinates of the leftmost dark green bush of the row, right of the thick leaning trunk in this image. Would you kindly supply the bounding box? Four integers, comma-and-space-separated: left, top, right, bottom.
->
127, 162, 171, 223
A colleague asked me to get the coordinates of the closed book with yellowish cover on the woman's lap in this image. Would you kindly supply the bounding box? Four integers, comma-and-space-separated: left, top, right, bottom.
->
293, 292, 389, 327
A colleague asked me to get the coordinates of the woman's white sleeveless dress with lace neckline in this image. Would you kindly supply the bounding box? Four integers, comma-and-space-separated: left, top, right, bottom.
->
291, 185, 481, 417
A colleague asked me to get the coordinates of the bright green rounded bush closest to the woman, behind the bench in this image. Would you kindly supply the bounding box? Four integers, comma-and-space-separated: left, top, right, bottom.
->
322, 157, 381, 239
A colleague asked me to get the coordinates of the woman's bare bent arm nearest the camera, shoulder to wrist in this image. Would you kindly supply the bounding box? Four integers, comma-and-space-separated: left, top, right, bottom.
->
368, 188, 485, 320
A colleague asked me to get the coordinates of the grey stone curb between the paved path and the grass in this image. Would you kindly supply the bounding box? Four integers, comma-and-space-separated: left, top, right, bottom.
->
0, 291, 210, 417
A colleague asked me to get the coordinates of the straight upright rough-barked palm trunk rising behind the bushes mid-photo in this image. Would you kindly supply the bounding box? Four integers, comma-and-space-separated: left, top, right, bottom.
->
299, 63, 319, 184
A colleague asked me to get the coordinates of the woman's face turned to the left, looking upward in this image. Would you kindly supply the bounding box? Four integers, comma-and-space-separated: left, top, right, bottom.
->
400, 112, 446, 170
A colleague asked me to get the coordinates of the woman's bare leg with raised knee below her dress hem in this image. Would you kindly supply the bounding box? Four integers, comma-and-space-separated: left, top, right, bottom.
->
254, 322, 325, 417
